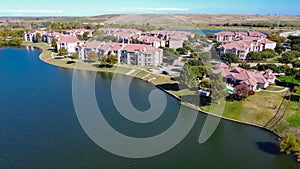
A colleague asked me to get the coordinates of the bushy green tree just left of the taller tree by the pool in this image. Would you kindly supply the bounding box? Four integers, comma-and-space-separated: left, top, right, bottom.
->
180, 64, 196, 88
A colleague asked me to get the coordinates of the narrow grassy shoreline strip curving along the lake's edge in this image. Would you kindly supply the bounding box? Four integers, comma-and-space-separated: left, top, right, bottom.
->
22, 43, 281, 138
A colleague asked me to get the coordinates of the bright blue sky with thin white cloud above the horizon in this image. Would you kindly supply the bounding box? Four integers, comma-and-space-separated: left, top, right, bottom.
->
0, 0, 300, 16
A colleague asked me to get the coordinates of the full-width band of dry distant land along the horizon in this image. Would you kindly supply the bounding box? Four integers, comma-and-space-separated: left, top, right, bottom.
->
0, 14, 300, 29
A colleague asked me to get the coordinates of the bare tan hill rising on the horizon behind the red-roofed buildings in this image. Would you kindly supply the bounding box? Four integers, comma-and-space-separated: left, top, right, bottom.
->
89, 14, 300, 28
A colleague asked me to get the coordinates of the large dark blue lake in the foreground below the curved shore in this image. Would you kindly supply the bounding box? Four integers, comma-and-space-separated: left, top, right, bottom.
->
0, 48, 300, 169
